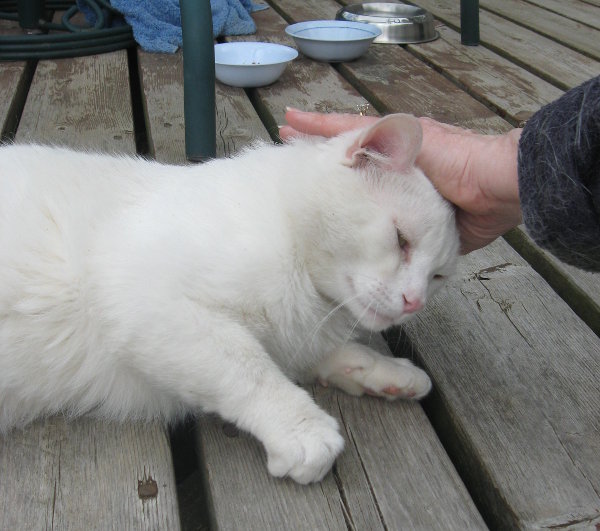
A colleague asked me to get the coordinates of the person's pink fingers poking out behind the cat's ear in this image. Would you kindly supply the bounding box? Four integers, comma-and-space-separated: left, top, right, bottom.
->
280, 108, 377, 138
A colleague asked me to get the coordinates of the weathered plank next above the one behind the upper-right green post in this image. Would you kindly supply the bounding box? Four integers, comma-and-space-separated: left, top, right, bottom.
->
480, 0, 600, 59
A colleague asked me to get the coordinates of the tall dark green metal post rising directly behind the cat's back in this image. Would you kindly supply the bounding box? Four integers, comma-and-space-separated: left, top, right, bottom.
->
179, 0, 217, 162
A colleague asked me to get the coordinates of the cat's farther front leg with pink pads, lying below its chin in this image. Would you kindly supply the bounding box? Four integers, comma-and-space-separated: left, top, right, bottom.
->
316, 343, 431, 400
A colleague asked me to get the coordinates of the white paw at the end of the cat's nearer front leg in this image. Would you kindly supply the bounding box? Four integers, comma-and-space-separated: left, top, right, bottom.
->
265, 411, 344, 485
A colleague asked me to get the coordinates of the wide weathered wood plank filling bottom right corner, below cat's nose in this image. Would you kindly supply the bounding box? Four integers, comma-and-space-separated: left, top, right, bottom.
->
398, 241, 600, 529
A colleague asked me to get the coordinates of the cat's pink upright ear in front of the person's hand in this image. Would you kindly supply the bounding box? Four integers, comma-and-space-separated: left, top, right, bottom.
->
344, 114, 423, 172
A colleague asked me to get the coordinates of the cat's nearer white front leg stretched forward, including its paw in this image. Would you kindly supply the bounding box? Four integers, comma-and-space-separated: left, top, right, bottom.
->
134, 316, 344, 484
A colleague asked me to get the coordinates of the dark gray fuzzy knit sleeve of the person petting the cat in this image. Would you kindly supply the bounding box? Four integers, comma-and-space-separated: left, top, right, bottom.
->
518, 76, 600, 271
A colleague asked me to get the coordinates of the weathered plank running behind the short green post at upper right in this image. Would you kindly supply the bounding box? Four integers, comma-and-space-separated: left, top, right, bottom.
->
398, 0, 600, 90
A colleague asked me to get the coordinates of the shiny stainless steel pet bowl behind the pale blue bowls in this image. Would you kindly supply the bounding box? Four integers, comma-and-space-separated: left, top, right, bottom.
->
335, 2, 439, 44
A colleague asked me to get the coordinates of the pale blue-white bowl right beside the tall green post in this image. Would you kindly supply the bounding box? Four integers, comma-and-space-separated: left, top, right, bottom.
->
215, 42, 298, 87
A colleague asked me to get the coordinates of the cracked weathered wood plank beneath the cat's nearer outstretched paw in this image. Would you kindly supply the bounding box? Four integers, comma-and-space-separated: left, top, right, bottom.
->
198, 332, 486, 530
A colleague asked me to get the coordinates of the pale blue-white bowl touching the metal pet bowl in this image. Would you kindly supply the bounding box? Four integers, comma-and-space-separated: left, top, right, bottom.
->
285, 20, 381, 62
